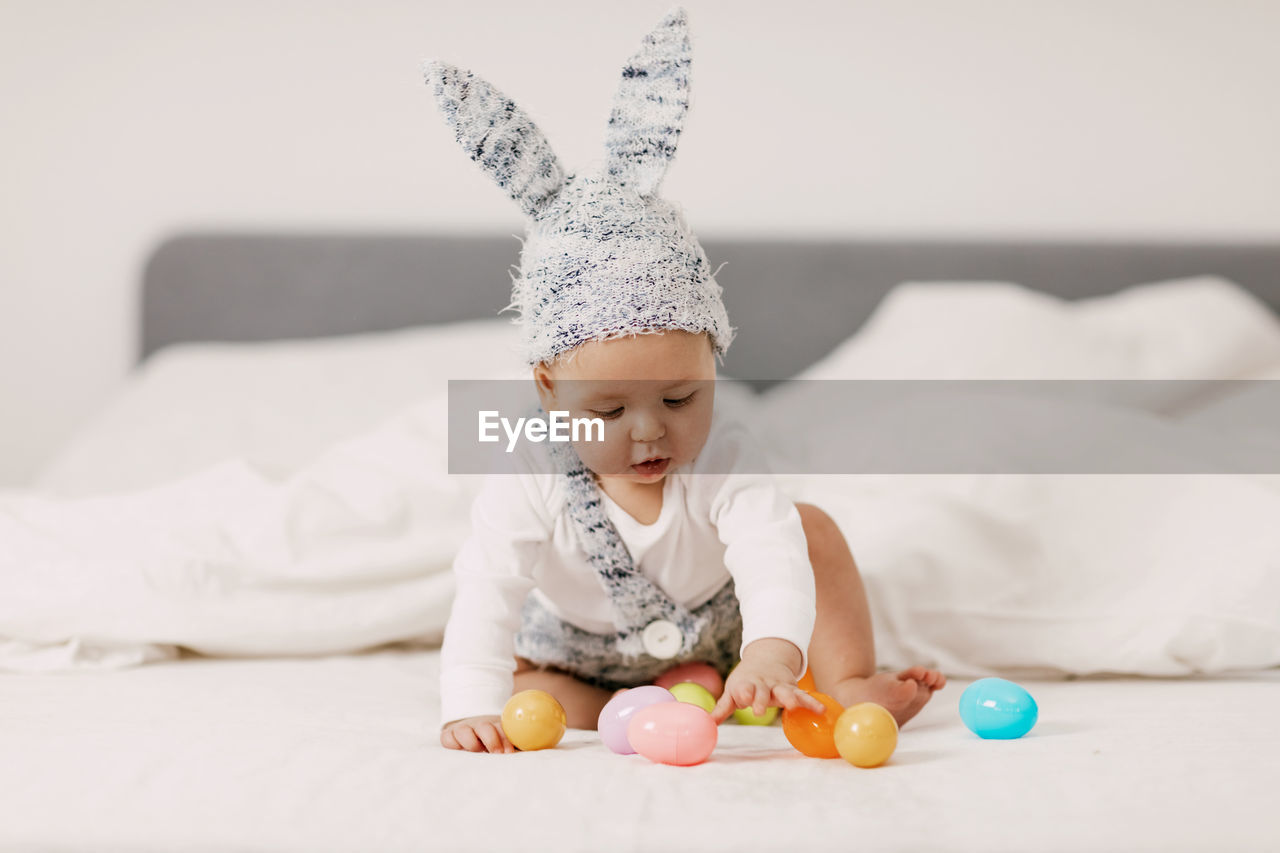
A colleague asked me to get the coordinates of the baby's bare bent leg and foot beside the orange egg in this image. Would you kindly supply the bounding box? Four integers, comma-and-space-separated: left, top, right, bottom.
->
796, 503, 947, 725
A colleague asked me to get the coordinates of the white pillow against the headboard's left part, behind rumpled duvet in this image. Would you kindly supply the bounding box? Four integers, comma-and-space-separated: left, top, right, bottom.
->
35, 319, 527, 497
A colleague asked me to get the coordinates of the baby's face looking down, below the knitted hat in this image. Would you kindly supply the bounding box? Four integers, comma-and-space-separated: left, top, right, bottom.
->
534, 329, 716, 484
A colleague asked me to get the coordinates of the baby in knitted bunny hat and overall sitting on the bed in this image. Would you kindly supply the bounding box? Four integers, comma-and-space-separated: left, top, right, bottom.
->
426, 9, 946, 752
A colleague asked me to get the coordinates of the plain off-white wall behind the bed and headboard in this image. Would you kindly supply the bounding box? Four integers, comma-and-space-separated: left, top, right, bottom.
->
0, 0, 1280, 485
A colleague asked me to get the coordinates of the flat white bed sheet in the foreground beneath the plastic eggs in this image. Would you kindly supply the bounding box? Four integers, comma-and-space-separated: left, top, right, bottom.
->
0, 648, 1280, 853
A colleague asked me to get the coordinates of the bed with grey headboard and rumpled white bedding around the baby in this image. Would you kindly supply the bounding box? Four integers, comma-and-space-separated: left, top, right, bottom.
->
0, 233, 1280, 850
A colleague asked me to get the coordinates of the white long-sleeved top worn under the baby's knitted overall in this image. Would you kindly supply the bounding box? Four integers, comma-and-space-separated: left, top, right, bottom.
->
440, 410, 815, 722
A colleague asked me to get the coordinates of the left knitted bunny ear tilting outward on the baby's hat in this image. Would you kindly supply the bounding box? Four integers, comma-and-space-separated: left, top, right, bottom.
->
425, 60, 564, 216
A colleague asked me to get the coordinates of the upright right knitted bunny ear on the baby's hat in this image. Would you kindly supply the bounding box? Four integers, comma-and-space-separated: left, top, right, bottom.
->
604, 8, 690, 196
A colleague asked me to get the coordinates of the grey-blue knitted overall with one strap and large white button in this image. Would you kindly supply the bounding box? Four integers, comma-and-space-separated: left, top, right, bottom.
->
516, 406, 742, 689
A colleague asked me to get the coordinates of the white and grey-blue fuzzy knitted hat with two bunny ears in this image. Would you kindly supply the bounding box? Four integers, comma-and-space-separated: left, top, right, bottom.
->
426, 8, 735, 366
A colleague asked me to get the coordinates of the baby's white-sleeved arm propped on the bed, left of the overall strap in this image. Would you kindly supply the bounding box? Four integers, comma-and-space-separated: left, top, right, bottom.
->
440, 474, 550, 752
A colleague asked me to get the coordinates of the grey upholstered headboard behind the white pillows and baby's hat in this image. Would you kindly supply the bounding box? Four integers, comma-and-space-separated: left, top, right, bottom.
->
140, 233, 1280, 384
